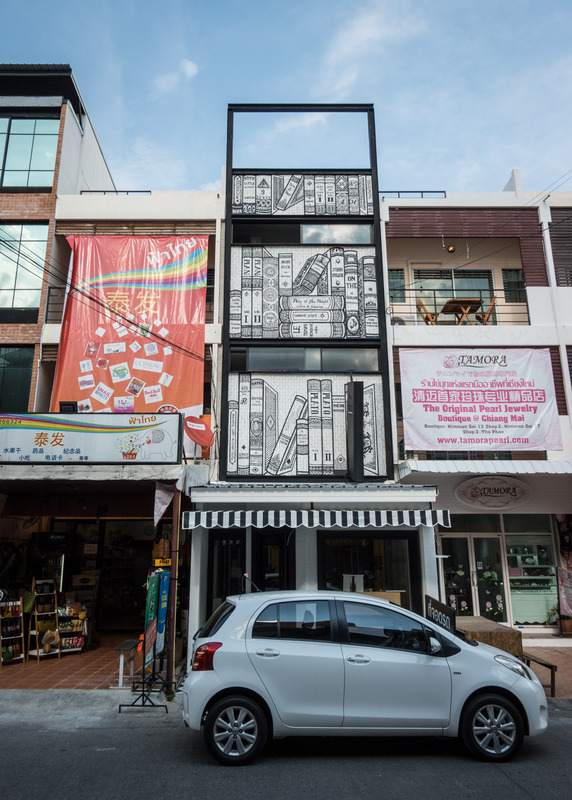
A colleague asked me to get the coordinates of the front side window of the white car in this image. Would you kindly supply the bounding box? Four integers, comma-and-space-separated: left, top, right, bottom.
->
343, 601, 429, 653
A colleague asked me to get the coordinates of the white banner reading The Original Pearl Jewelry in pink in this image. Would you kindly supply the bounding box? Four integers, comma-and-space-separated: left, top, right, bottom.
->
399, 348, 562, 451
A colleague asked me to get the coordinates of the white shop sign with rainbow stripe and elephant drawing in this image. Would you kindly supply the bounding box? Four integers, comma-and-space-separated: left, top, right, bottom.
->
0, 412, 182, 464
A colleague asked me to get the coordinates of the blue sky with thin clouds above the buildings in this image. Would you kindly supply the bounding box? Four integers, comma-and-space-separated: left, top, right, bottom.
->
0, 0, 572, 191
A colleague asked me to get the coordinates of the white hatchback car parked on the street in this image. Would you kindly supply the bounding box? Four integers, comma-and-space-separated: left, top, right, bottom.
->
182, 591, 548, 764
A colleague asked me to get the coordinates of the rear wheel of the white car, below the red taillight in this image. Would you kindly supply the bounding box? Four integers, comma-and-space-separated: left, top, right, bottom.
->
203, 696, 268, 766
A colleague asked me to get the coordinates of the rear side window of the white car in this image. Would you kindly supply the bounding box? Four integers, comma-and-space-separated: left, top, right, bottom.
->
252, 600, 332, 642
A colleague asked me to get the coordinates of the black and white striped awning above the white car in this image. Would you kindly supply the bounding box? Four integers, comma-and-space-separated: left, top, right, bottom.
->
183, 509, 451, 530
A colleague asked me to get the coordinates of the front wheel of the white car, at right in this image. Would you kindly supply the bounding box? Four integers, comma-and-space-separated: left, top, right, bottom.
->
461, 694, 524, 762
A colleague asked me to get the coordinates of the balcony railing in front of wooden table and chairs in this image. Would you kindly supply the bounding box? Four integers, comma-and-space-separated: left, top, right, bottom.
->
389, 289, 530, 326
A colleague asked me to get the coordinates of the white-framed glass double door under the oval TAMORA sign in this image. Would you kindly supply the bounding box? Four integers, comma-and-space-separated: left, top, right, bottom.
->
440, 535, 507, 622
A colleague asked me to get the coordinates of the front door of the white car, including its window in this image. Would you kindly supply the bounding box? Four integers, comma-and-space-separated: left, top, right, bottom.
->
339, 601, 451, 729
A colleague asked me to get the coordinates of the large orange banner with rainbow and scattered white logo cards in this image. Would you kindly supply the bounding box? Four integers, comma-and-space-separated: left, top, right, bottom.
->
51, 236, 208, 451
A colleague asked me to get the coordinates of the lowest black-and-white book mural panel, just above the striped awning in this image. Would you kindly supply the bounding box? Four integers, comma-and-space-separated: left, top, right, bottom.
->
227, 373, 385, 477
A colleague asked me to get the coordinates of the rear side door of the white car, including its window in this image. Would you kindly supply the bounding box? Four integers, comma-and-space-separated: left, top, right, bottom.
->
242, 600, 344, 728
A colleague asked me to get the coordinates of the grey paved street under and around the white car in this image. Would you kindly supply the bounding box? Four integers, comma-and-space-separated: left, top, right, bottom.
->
0, 690, 572, 800
